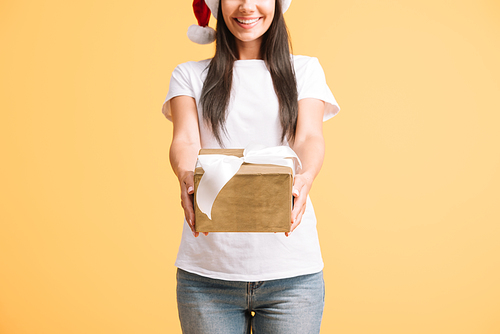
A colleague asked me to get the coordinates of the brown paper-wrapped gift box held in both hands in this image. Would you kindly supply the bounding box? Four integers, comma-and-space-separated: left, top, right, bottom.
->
194, 149, 293, 232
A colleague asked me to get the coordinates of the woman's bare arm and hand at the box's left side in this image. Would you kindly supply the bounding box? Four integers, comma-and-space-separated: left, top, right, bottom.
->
170, 96, 201, 237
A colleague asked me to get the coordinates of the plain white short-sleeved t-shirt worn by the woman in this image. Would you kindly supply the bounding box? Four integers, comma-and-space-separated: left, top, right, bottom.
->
162, 55, 340, 282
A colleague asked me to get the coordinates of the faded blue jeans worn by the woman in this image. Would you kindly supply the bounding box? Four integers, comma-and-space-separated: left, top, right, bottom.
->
177, 269, 325, 334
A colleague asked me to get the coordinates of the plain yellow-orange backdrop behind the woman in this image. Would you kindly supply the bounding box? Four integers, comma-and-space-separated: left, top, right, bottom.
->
0, 0, 500, 334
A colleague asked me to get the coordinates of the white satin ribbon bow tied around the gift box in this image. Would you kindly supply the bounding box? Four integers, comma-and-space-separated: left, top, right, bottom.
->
196, 145, 302, 219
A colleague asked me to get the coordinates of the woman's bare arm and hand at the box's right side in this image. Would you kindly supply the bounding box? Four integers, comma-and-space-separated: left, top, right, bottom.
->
285, 98, 325, 236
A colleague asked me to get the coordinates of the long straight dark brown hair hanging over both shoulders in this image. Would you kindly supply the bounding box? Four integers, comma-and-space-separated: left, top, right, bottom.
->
200, 0, 299, 147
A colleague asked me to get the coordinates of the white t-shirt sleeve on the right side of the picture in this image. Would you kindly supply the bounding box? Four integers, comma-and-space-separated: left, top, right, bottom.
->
297, 57, 340, 121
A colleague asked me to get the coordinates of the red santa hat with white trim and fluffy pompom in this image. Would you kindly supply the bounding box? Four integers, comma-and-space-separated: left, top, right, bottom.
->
188, 0, 292, 44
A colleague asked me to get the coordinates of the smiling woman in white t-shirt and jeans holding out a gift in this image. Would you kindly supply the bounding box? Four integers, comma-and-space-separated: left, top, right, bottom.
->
162, 0, 340, 333
